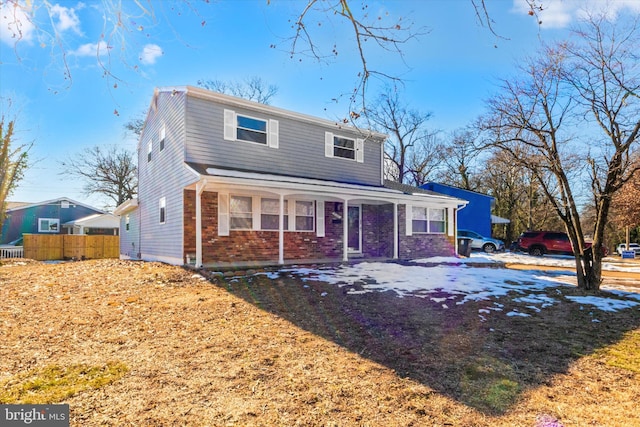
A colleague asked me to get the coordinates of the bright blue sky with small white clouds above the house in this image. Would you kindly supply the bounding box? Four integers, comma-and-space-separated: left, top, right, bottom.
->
0, 0, 640, 211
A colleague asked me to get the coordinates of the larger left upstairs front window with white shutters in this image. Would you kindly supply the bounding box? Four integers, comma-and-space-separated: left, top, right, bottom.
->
224, 110, 278, 148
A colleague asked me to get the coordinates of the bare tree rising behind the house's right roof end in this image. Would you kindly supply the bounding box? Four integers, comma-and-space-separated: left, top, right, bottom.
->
365, 87, 437, 184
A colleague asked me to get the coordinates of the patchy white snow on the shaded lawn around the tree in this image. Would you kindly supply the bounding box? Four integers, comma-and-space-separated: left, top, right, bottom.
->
280, 253, 640, 321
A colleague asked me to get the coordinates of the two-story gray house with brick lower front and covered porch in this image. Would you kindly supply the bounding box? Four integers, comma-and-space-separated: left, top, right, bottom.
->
115, 86, 466, 266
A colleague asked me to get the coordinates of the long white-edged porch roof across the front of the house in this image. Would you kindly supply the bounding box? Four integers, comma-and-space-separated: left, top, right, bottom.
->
186, 163, 468, 207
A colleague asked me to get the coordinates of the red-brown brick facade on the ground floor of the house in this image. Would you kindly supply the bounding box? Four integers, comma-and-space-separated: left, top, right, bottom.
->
184, 190, 454, 265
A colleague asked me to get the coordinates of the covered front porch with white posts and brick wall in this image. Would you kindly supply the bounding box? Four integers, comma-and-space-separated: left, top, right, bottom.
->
184, 168, 459, 267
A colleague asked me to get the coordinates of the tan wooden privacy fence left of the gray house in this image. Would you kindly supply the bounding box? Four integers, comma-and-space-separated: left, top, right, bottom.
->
23, 234, 120, 261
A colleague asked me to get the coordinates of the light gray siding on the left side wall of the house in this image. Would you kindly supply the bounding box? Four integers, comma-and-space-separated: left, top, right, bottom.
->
138, 92, 197, 259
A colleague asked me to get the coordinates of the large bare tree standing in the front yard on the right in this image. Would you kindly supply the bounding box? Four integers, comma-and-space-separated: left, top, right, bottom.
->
483, 16, 640, 290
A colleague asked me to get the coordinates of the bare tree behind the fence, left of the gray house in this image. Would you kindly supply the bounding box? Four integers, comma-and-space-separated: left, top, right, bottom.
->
60, 146, 138, 210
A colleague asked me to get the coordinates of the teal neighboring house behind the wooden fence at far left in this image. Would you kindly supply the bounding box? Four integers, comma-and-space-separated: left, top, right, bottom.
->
0, 197, 104, 244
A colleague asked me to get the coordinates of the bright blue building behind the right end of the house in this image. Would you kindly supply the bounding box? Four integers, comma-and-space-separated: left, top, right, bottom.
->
420, 182, 495, 237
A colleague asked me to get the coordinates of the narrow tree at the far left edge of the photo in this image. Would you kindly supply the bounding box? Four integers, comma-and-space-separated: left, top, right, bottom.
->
0, 115, 31, 234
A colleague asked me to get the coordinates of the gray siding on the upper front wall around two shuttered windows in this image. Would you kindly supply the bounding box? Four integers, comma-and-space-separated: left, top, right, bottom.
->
185, 96, 382, 185
